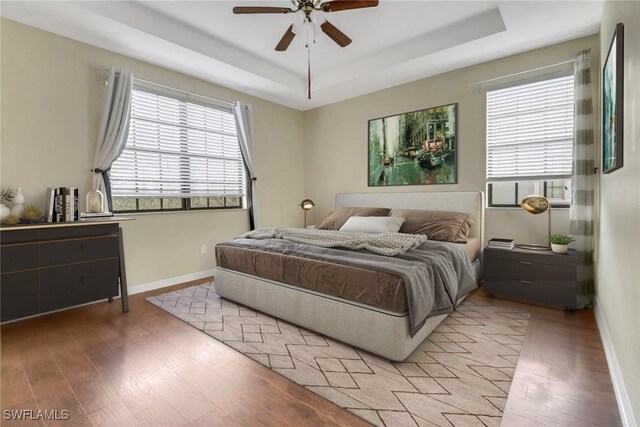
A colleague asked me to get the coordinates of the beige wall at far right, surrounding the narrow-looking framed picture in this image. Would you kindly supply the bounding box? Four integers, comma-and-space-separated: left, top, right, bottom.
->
596, 1, 640, 425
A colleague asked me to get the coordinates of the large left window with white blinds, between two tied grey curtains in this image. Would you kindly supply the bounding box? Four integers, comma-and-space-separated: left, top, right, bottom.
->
110, 83, 245, 212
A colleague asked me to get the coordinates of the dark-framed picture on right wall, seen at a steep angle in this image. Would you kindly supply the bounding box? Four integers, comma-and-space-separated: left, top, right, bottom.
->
602, 23, 624, 173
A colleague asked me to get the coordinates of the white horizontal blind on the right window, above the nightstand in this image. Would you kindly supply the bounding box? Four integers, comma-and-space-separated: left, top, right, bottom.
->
487, 75, 574, 181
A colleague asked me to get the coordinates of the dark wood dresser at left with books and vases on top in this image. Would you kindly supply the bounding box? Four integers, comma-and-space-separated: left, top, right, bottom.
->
0, 217, 129, 322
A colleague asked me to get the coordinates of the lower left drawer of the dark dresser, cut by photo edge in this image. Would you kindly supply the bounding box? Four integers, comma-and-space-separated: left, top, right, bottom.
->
0, 270, 39, 322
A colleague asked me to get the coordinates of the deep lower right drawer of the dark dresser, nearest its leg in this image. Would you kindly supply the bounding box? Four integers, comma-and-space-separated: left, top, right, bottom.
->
40, 259, 119, 312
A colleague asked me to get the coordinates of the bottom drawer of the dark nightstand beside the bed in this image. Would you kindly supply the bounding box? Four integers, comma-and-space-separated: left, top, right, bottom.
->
483, 280, 577, 310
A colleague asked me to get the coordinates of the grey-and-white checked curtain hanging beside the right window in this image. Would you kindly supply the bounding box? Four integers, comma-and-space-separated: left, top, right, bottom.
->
570, 50, 595, 307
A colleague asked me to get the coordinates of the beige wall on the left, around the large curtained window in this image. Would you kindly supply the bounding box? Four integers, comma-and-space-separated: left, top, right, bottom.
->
0, 19, 304, 286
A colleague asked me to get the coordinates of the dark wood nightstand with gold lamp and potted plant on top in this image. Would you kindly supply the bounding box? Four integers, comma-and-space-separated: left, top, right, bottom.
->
483, 247, 577, 310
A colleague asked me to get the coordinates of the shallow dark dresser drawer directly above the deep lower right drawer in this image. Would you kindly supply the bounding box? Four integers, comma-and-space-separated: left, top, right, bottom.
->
40, 236, 118, 267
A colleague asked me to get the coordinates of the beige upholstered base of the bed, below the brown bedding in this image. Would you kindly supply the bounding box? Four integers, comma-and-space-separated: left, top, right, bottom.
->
214, 263, 479, 361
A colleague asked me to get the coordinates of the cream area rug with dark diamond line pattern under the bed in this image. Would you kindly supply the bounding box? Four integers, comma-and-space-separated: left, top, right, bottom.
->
147, 283, 529, 426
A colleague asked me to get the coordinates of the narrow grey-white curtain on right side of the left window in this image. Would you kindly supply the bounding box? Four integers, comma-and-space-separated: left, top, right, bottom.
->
233, 101, 258, 230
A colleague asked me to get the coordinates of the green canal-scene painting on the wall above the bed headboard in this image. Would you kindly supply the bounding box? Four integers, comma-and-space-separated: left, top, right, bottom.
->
368, 103, 458, 187
